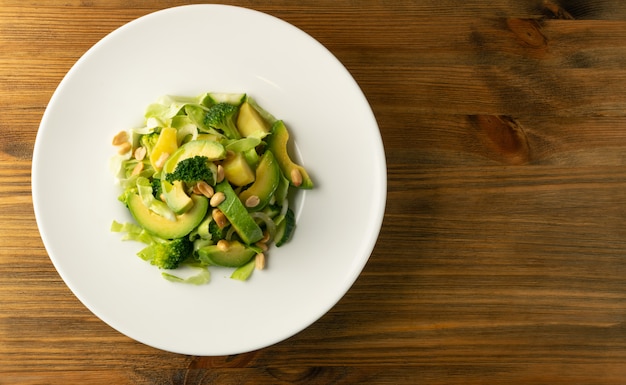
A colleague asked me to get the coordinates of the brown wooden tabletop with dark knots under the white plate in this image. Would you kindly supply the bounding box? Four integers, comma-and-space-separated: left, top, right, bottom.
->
0, 0, 626, 384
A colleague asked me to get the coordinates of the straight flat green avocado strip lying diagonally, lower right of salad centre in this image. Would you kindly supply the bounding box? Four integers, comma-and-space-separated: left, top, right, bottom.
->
215, 180, 263, 245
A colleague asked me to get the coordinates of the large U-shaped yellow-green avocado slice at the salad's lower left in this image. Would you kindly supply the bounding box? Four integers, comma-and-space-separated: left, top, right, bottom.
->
126, 194, 209, 239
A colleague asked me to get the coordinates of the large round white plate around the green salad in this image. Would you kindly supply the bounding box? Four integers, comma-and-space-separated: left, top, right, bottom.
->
32, 5, 387, 355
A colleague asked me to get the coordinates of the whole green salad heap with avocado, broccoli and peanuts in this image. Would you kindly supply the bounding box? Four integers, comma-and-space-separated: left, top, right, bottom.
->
111, 93, 313, 284
